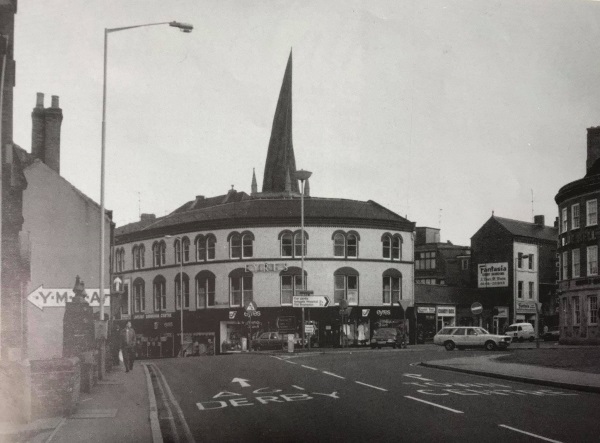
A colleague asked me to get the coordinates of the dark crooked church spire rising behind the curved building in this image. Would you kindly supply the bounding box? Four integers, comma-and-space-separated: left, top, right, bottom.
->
262, 51, 300, 192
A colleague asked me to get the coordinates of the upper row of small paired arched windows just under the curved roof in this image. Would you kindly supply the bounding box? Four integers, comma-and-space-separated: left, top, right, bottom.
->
115, 230, 403, 272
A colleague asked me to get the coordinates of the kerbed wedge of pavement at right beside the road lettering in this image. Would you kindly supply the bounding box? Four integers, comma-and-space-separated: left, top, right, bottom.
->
420, 353, 600, 393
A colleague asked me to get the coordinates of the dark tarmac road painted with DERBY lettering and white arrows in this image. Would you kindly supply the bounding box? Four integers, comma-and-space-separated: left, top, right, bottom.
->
154, 348, 600, 442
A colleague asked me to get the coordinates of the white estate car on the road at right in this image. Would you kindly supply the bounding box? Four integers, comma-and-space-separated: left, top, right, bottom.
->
433, 326, 512, 351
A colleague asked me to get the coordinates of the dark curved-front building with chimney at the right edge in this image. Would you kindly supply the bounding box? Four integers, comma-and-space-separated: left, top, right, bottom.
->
555, 127, 600, 344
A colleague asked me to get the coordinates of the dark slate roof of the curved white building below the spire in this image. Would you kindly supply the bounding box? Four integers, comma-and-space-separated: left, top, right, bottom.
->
115, 193, 414, 242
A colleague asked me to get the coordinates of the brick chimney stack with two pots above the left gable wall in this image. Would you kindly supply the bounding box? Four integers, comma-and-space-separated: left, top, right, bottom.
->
31, 92, 63, 174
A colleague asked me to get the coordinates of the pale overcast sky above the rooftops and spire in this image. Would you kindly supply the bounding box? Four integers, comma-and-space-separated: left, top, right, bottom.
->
14, 0, 600, 245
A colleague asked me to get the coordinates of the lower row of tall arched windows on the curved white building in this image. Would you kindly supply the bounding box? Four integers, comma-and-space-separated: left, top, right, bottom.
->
132, 267, 402, 313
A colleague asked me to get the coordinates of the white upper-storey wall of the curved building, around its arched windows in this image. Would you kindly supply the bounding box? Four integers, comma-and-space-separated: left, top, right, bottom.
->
117, 226, 414, 313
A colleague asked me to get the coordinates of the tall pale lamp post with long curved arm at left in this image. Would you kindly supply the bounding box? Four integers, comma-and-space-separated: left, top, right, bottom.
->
98, 21, 194, 373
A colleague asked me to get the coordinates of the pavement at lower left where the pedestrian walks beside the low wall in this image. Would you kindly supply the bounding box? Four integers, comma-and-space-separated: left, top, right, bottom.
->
0, 361, 157, 443
